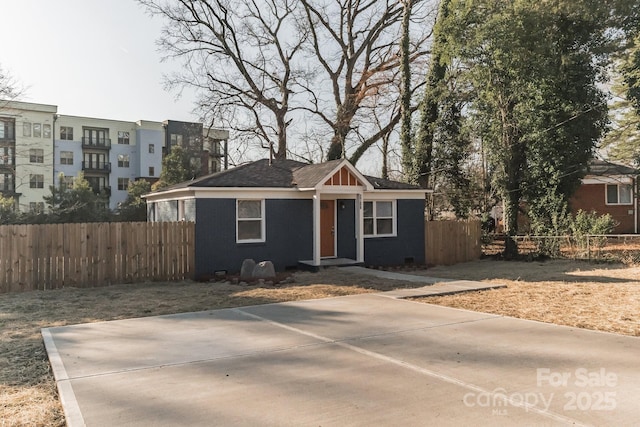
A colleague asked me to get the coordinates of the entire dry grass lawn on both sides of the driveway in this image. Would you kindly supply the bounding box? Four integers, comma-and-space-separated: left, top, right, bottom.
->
0, 260, 640, 427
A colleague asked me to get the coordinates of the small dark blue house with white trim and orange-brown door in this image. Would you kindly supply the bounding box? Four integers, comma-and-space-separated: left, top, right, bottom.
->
145, 160, 427, 278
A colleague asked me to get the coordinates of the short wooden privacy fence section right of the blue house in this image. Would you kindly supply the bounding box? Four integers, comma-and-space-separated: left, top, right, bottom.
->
425, 220, 482, 265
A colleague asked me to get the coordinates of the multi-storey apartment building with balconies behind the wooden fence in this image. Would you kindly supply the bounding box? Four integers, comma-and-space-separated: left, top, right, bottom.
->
0, 101, 229, 212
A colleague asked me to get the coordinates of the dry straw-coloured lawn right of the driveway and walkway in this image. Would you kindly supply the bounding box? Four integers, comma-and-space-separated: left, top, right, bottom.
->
418, 260, 640, 336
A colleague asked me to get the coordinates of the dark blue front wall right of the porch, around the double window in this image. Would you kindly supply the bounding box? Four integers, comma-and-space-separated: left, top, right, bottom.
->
364, 200, 425, 265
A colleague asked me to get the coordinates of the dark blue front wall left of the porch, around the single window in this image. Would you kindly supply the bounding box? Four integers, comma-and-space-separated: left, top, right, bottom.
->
195, 199, 313, 278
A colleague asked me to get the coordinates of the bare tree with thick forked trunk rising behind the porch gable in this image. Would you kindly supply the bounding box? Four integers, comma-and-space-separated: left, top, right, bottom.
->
300, 0, 430, 162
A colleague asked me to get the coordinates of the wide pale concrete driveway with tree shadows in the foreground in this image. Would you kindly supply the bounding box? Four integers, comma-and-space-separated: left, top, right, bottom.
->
43, 294, 640, 427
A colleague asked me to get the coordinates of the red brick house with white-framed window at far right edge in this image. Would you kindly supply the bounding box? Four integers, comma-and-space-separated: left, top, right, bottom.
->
570, 160, 639, 234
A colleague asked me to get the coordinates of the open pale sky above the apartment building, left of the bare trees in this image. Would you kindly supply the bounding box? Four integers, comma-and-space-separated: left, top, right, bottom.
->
0, 0, 198, 121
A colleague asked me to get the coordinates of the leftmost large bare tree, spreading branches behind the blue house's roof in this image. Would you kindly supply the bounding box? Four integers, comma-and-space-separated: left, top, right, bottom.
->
138, 0, 305, 158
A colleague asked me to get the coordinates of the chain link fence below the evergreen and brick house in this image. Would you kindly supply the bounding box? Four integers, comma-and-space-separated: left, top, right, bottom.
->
482, 234, 640, 264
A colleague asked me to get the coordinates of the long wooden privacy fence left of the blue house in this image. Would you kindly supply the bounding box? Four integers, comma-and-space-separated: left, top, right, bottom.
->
0, 222, 195, 293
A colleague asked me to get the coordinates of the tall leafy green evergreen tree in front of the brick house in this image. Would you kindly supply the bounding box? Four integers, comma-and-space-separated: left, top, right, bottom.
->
444, 0, 610, 257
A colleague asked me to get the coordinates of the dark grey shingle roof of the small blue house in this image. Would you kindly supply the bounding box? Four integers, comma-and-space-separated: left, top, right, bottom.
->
156, 159, 420, 191
